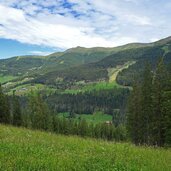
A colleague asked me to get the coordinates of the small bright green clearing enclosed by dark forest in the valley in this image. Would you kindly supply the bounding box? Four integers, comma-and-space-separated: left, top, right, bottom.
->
58, 112, 112, 124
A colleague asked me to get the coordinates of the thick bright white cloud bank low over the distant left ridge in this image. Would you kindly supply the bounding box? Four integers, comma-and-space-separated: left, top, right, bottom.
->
0, 6, 115, 48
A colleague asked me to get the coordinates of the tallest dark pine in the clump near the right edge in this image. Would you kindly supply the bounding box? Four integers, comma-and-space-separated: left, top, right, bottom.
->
153, 58, 168, 146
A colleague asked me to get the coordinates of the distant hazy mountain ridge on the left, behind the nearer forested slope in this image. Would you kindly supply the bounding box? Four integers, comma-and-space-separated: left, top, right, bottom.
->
0, 43, 150, 76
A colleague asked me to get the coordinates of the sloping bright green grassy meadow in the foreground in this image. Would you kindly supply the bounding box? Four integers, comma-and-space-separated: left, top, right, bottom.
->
0, 125, 171, 171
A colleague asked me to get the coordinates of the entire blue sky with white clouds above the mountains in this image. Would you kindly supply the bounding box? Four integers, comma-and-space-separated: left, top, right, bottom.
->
0, 0, 171, 58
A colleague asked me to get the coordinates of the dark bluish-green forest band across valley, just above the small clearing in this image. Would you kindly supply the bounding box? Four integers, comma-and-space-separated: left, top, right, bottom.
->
45, 88, 130, 115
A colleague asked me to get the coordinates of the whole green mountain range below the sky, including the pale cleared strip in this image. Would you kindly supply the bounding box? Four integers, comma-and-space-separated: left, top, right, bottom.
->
0, 37, 171, 92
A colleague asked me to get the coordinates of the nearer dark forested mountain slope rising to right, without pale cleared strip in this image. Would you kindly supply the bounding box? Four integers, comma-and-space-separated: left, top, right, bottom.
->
30, 37, 171, 85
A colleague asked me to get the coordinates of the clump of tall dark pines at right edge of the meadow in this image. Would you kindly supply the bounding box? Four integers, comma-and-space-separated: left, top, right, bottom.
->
127, 58, 171, 146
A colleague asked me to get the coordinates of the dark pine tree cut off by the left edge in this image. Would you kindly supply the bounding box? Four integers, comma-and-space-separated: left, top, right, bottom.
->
0, 84, 10, 124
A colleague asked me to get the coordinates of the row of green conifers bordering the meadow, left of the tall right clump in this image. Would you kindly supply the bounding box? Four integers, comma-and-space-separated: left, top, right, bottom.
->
0, 86, 127, 141
